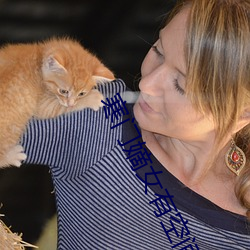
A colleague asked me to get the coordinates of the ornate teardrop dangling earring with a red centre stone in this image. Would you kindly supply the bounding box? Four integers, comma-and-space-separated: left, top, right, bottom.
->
225, 139, 246, 175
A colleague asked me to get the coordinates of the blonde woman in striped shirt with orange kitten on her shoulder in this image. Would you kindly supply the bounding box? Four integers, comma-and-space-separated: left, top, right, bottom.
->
22, 0, 250, 250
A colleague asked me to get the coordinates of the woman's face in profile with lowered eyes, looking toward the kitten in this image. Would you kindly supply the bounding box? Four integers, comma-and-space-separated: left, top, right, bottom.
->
134, 8, 214, 143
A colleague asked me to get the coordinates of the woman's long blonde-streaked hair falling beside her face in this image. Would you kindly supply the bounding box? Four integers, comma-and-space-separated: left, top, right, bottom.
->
168, 0, 250, 218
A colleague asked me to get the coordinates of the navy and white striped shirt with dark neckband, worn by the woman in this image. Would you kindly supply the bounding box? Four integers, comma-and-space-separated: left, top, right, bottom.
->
21, 80, 250, 250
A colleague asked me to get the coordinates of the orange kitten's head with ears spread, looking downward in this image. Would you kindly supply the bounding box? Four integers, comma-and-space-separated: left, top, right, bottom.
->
42, 39, 114, 107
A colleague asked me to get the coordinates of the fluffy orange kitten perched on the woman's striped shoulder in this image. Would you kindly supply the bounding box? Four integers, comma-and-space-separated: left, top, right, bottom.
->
0, 39, 114, 168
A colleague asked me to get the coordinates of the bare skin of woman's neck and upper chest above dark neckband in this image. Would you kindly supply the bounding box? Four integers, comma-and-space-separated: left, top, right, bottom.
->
142, 130, 246, 215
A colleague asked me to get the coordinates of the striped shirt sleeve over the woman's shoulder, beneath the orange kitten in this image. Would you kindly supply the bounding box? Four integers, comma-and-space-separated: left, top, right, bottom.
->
21, 79, 130, 166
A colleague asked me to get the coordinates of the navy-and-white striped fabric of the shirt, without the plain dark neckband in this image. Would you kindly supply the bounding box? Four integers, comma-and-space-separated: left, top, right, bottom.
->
22, 80, 250, 250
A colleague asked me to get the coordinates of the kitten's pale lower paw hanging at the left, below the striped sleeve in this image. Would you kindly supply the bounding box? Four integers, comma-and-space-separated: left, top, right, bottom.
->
6, 145, 27, 167
